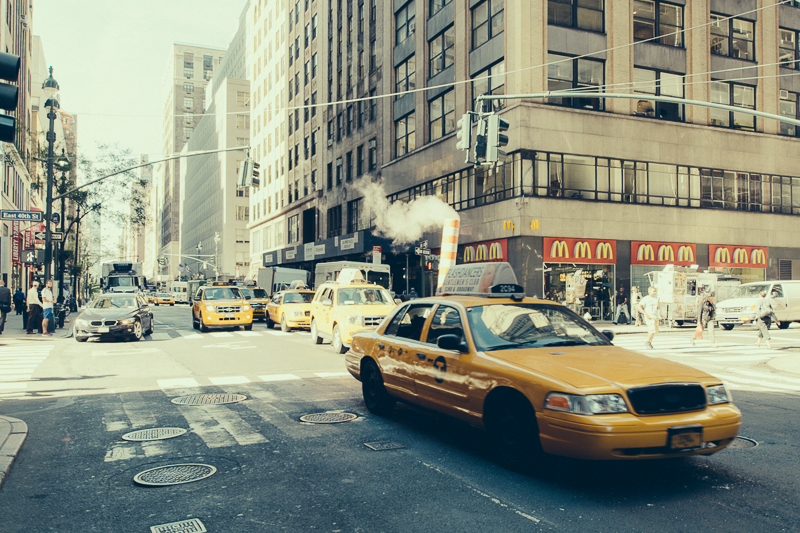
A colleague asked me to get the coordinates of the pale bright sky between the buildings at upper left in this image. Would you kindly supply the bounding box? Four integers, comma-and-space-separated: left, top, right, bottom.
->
32, 0, 246, 159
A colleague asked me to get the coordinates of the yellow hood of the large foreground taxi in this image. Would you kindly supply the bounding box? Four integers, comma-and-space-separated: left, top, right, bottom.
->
484, 346, 719, 390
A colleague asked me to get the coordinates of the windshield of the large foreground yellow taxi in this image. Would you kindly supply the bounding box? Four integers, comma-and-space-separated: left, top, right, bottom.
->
467, 303, 610, 351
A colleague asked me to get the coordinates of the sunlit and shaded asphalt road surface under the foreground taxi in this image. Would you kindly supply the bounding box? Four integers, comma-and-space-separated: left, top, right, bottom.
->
0, 306, 800, 533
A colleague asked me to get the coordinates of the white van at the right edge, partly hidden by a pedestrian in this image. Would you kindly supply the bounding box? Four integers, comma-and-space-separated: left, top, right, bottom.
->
717, 280, 800, 330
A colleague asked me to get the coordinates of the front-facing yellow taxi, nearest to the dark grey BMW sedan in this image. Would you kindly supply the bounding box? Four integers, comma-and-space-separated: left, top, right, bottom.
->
192, 281, 253, 332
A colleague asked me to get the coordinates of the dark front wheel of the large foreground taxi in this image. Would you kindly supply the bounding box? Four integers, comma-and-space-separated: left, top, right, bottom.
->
484, 395, 544, 472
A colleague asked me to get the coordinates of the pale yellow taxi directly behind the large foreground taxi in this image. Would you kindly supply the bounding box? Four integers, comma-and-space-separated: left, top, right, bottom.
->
311, 268, 396, 353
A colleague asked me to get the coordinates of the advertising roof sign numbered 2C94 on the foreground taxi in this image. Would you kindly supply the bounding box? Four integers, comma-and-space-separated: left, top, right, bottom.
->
436, 263, 525, 297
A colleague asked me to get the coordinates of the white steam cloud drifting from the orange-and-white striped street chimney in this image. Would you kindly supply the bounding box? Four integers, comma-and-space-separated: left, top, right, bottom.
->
361, 183, 459, 246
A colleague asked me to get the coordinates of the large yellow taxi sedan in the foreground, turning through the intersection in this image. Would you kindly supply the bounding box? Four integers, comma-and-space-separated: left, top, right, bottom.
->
345, 263, 741, 468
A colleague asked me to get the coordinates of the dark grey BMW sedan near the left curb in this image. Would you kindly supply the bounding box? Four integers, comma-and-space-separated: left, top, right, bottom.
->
73, 292, 154, 342
